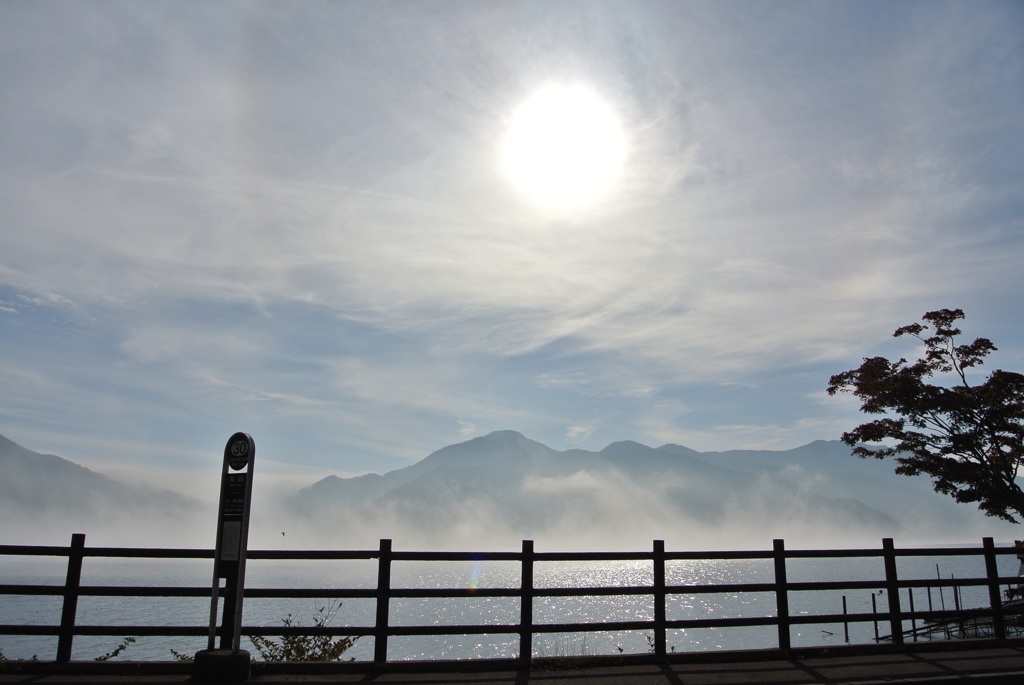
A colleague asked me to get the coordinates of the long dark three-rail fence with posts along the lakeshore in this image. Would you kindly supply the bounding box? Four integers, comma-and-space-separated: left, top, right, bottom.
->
0, 533, 1021, 666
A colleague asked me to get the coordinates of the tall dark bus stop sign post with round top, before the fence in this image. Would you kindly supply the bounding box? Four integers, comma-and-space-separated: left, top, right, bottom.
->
208, 433, 256, 652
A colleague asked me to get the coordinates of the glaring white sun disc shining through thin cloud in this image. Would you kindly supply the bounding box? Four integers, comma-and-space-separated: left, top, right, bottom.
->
501, 84, 626, 211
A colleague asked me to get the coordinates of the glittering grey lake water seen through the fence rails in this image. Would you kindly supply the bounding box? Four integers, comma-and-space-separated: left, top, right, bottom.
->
0, 544, 1019, 660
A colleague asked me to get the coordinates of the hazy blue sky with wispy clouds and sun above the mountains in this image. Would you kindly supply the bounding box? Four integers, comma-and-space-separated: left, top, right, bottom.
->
0, 0, 1024, 488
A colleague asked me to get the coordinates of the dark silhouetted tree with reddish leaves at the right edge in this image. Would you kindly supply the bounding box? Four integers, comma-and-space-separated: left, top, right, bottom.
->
828, 309, 1024, 523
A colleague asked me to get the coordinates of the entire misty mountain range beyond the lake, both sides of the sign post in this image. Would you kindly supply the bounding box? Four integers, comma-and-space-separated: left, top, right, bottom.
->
0, 431, 1015, 550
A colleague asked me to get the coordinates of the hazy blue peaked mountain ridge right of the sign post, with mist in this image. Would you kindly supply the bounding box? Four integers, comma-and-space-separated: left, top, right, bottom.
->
286, 431, 1015, 548
